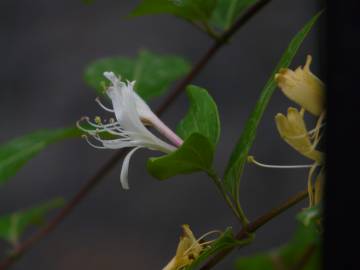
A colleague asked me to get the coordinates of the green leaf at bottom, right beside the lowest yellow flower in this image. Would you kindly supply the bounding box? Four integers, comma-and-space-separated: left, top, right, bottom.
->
184, 228, 242, 270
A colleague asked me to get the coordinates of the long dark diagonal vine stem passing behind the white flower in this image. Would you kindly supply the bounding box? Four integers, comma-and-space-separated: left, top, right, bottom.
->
0, 0, 271, 270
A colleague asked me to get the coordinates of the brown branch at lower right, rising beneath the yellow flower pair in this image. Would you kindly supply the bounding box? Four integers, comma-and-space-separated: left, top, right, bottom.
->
200, 190, 308, 270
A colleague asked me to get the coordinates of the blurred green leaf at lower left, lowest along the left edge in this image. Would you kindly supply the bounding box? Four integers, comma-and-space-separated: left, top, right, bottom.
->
0, 198, 64, 245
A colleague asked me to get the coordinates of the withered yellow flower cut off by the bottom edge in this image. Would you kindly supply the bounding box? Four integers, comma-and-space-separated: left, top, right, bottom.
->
162, 224, 219, 270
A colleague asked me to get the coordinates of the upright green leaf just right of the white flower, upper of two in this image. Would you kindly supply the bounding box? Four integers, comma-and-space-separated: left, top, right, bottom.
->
177, 85, 220, 146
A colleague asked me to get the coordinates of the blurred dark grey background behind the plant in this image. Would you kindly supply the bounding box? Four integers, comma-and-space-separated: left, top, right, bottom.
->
0, 0, 319, 270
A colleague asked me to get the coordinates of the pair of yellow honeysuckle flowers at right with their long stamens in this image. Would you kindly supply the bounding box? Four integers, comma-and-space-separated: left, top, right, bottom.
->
248, 55, 326, 207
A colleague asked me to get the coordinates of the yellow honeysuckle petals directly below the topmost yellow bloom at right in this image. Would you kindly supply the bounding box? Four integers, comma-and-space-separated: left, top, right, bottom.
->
275, 107, 324, 164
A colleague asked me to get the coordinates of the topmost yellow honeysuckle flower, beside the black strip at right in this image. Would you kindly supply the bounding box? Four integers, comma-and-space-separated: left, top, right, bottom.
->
275, 55, 325, 116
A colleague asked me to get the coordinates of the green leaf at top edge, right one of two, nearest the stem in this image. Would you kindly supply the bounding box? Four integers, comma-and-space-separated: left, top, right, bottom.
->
211, 0, 256, 30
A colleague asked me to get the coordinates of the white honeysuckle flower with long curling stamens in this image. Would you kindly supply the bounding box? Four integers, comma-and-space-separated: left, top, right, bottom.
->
77, 72, 183, 189
